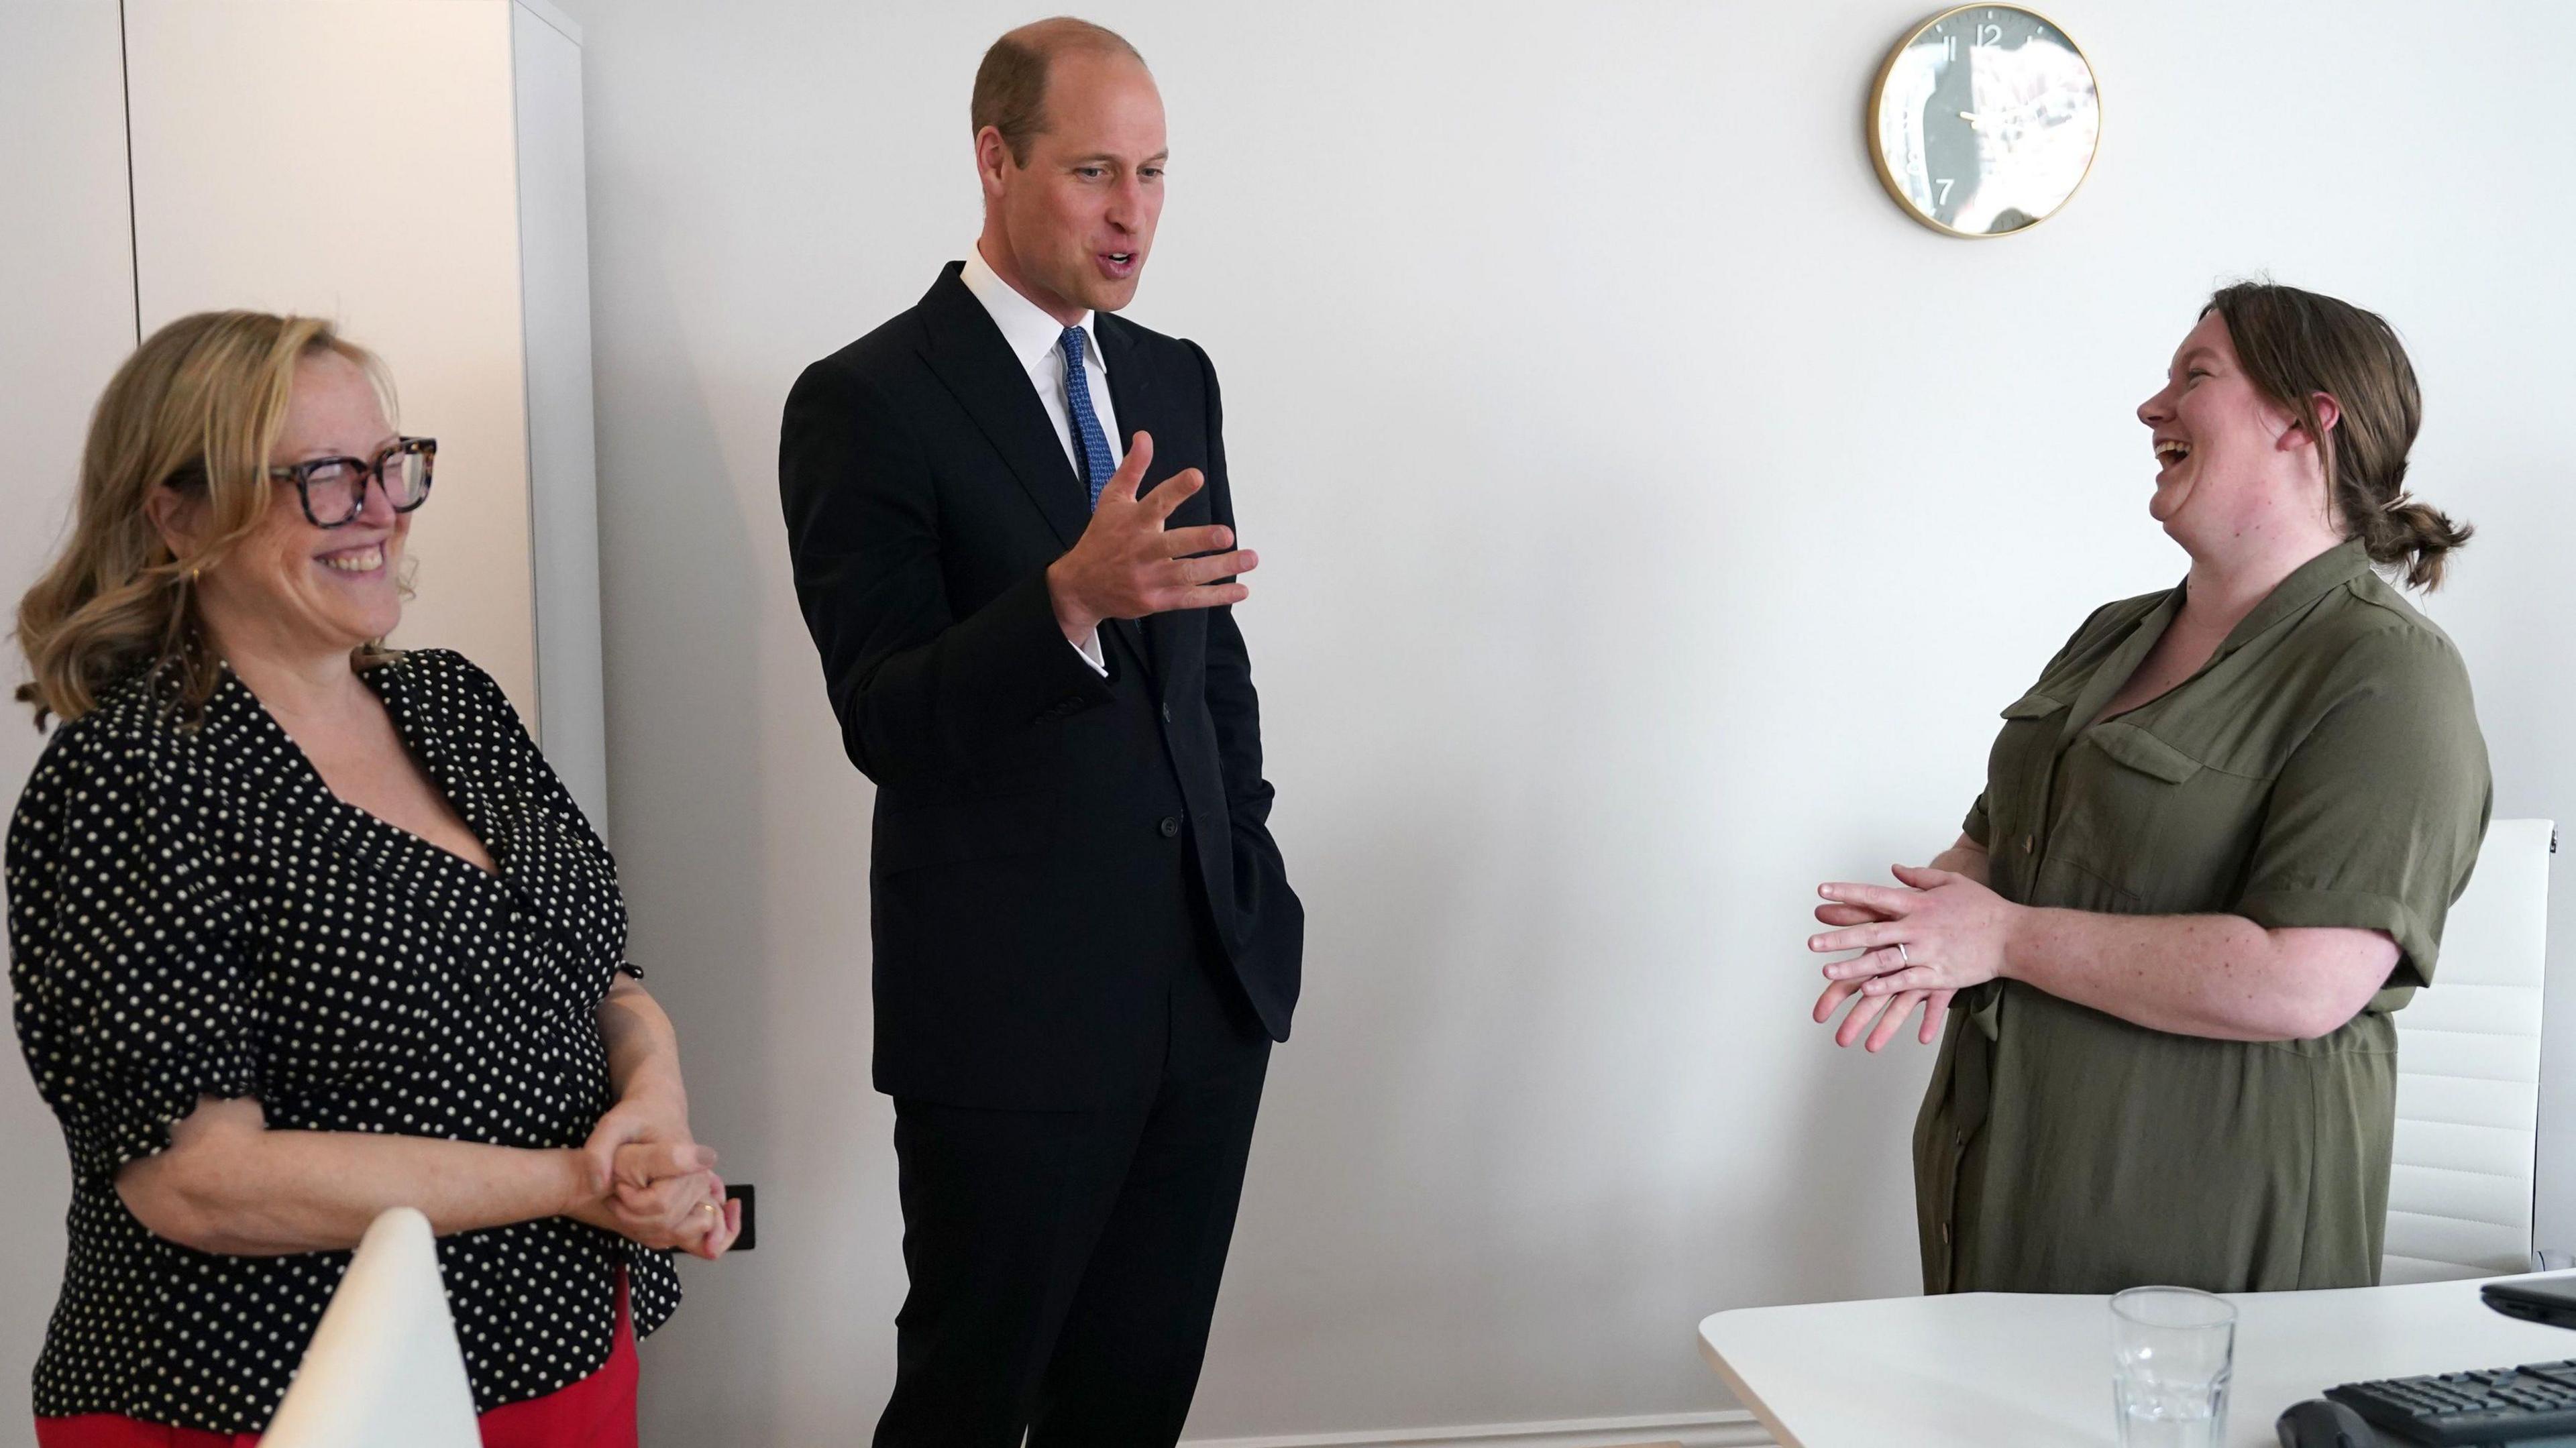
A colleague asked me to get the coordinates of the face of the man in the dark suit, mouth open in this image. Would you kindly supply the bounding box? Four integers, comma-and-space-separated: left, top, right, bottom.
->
976, 52, 1167, 325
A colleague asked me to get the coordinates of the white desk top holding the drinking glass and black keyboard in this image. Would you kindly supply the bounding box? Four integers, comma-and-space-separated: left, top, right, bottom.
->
1700, 1268, 2576, 1448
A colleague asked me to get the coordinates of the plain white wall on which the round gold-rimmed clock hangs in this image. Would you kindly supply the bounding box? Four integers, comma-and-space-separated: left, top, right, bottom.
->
572, 0, 2576, 1445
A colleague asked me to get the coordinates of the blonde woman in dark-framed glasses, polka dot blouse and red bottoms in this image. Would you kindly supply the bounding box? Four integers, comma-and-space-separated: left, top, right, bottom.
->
8, 312, 739, 1448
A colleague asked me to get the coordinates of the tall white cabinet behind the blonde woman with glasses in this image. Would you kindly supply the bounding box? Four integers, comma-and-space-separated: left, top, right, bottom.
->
0, 0, 608, 832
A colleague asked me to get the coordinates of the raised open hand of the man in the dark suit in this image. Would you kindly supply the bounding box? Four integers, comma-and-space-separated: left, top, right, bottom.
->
1046, 433, 1260, 642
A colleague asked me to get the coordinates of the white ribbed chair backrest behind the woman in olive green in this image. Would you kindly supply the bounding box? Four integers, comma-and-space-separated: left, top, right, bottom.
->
2380, 820, 2553, 1283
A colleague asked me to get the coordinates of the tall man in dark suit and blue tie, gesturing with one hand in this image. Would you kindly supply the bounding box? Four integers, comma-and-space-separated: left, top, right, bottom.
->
778, 21, 1303, 1448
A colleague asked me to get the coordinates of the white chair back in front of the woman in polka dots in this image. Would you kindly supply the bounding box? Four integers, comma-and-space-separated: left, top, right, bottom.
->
260, 1206, 482, 1448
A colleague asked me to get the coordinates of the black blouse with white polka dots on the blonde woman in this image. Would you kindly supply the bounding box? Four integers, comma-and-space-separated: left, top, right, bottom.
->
8, 649, 680, 1433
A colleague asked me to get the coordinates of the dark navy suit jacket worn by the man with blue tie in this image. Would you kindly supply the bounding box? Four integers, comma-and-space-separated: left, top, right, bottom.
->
778, 263, 1306, 1108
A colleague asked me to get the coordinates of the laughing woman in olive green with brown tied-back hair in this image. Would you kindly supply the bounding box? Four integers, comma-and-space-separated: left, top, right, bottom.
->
1809, 286, 2491, 1294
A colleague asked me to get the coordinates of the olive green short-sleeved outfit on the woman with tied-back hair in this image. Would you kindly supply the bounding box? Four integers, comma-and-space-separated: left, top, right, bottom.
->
1914, 544, 2493, 1294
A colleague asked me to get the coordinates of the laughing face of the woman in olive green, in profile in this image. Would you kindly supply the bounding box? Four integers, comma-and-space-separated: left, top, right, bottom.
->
2138, 312, 2331, 546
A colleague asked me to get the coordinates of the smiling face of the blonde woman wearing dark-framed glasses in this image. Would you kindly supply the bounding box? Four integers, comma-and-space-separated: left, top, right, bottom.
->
199, 353, 412, 655
